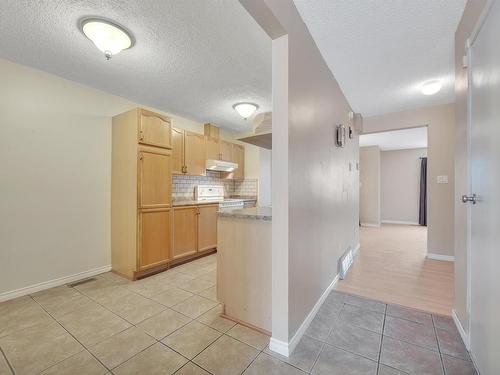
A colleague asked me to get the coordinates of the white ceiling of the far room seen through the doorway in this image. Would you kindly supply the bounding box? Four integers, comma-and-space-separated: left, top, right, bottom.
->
359, 126, 427, 151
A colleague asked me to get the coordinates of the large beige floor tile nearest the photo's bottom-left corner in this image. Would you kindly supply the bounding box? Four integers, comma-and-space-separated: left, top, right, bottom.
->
0, 321, 83, 375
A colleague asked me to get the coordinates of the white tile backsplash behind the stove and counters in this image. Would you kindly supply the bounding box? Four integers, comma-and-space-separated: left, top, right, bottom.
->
172, 171, 257, 200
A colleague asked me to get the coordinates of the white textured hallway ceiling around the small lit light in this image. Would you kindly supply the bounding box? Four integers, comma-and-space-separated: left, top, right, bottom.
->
294, 0, 466, 117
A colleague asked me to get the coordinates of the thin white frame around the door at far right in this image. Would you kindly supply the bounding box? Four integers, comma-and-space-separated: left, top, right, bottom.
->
464, 0, 497, 358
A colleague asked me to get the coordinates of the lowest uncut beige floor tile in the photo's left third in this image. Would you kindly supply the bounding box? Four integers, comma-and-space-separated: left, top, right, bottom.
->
89, 327, 155, 369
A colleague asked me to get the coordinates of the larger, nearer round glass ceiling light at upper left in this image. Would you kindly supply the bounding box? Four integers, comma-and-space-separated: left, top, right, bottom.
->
80, 17, 134, 60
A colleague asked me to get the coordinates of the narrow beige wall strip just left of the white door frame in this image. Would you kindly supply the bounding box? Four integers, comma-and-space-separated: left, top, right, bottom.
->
454, 0, 486, 330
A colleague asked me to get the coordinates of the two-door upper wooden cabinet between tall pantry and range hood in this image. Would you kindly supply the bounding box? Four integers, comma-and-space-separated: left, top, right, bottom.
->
172, 128, 205, 176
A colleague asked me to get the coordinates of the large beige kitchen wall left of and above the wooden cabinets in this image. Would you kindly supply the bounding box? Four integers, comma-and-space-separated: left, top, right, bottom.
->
0, 59, 258, 299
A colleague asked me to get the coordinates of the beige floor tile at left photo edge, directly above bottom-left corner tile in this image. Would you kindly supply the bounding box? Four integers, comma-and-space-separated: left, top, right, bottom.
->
0, 297, 54, 337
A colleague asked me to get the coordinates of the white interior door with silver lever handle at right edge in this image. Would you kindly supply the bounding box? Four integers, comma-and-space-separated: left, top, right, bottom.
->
469, 1, 500, 375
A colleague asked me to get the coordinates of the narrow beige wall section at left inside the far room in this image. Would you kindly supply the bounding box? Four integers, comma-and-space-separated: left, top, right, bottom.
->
359, 146, 381, 226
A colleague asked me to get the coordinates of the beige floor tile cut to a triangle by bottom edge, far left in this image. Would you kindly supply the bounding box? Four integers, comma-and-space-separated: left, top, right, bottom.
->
41, 350, 108, 375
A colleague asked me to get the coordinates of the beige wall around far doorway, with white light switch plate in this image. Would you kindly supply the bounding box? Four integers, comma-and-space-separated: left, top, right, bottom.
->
363, 104, 455, 256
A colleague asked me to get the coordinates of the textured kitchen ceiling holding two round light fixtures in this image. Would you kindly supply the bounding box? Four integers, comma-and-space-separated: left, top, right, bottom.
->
0, 0, 271, 130
